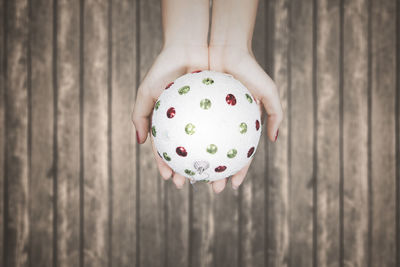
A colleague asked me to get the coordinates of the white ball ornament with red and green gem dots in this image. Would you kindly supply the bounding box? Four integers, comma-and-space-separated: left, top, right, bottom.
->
151, 71, 262, 182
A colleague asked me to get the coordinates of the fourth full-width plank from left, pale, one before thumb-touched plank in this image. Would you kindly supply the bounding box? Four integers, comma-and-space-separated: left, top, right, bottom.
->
83, 0, 110, 266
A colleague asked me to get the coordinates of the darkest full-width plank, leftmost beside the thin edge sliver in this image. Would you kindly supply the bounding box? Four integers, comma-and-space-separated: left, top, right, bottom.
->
4, 0, 29, 267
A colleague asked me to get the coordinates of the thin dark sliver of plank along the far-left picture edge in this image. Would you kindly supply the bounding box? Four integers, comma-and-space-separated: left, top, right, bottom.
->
0, 1, 7, 264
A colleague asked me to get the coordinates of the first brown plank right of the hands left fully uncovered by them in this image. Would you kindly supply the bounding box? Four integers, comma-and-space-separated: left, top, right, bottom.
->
288, 0, 315, 266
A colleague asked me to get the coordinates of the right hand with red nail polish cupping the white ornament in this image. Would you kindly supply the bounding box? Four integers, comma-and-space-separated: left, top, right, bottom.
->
209, 45, 283, 193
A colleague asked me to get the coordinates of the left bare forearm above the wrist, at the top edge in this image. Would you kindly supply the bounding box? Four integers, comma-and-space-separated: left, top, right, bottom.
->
161, 0, 209, 47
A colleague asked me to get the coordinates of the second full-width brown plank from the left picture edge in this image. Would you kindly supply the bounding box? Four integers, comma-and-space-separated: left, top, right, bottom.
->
29, 1, 55, 266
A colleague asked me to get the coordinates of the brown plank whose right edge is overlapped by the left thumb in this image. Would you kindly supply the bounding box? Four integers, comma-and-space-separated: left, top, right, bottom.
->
111, 0, 136, 267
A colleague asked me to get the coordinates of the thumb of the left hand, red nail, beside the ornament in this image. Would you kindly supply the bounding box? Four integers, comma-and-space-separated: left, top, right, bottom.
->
132, 86, 155, 144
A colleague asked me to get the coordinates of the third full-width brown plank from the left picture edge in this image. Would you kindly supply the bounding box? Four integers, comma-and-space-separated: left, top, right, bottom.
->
56, 0, 80, 267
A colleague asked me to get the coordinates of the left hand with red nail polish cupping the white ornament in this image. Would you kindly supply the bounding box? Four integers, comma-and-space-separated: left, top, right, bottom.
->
132, 44, 208, 188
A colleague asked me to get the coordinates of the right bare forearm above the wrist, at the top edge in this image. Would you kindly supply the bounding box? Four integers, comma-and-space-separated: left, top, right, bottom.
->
210, 0, 258, 50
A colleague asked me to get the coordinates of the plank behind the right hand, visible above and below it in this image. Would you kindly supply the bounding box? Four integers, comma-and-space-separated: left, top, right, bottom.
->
239, 1, 267, 266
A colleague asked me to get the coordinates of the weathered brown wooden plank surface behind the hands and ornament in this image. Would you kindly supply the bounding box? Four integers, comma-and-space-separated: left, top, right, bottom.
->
0, 0, 400, 267
